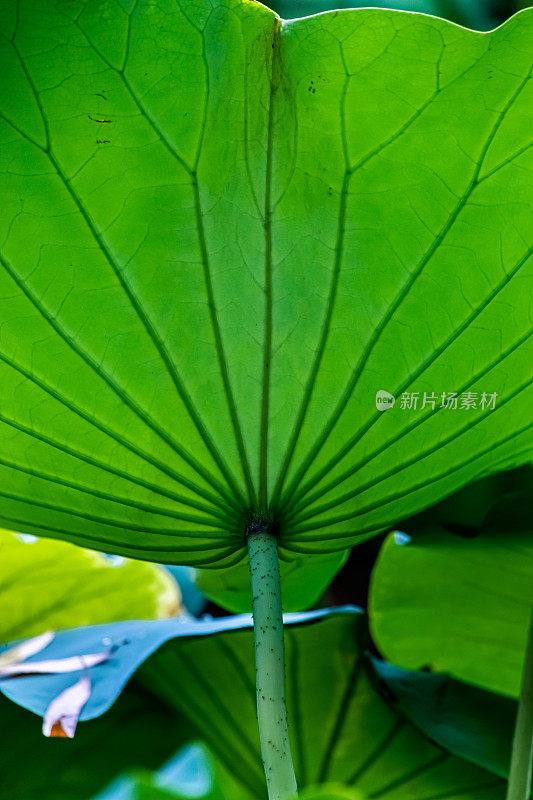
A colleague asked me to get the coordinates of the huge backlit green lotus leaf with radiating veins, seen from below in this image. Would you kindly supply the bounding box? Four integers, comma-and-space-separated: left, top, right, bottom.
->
0, 0, 533, 565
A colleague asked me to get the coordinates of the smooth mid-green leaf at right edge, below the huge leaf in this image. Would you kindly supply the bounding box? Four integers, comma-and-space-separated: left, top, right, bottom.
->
370, 520, 533, 697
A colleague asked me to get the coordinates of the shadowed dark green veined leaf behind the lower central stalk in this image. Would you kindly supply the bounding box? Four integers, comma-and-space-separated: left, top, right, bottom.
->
137, 610, 516, 800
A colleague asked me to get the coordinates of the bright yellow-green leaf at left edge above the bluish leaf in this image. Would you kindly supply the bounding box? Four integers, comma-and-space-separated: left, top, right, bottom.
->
0, 531, 180, 642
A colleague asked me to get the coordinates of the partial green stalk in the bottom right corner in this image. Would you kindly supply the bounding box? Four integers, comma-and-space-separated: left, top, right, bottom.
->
507, 614, 533, 800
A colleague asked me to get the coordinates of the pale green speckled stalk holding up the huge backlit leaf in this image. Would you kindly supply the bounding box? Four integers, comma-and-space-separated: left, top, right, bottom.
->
248, 523, 297, 800
